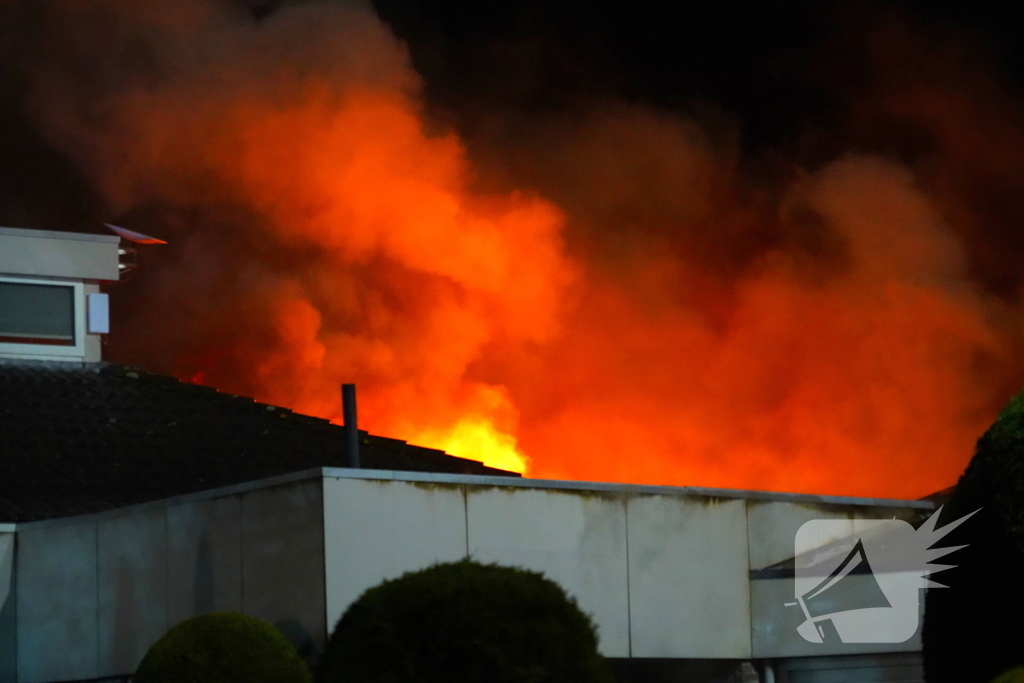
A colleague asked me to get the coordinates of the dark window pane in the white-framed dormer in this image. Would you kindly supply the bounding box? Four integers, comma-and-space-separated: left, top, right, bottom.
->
0, 283, 75, 344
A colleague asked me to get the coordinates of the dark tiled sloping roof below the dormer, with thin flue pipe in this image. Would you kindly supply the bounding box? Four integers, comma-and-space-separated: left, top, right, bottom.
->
0, 361, 518, 522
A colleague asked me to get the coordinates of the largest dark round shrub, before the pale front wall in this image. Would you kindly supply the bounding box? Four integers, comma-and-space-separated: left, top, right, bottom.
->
317, 560, 611, 683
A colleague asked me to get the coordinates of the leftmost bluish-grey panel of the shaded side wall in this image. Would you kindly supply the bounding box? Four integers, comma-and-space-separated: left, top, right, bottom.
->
15, 523, 99, 683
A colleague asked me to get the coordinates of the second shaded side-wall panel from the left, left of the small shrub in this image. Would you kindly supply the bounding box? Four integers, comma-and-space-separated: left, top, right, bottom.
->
96, 510, 169, 676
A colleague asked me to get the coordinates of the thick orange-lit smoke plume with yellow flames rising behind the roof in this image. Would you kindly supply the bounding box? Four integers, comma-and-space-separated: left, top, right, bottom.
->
8, 0, 1024, 497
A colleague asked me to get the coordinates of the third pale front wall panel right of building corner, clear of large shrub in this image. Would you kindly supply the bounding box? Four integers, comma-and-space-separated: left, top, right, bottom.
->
627, 496, 751, 658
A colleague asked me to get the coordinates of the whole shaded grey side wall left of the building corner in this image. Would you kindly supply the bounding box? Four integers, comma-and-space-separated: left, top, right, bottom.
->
11, 478, 327, 683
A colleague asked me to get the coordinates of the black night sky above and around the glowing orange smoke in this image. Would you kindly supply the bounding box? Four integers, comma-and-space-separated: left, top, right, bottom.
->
6, 0, 1024, 286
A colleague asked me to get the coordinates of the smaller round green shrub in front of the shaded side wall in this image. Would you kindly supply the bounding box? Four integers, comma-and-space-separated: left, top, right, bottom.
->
135, 612, 311, 683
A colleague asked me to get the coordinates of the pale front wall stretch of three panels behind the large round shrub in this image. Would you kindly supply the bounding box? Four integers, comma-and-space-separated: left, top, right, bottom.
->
324, 477, 751, 658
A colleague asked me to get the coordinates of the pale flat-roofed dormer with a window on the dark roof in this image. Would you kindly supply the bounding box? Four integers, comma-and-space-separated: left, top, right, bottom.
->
0, 227, 121, 362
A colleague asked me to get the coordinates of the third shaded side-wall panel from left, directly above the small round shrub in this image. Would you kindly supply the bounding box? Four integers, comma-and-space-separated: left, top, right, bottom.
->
167, 496, 242, 627
